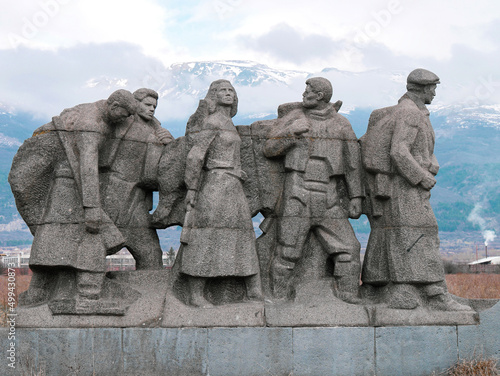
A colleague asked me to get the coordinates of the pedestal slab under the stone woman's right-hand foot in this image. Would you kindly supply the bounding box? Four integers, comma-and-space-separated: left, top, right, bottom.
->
208, 328, 293, 376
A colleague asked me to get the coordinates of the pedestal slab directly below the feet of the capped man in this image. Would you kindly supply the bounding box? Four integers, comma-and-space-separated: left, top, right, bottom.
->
375, 326, 458, 376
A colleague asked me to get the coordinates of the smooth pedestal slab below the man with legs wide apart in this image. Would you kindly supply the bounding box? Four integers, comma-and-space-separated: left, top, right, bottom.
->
292, 328, 375, 375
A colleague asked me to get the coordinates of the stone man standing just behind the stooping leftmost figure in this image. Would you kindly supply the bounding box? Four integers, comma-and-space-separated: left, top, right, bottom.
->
100, 88, 173, 270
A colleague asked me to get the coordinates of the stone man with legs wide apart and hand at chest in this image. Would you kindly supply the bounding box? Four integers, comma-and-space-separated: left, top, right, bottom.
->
263, 77, 363, 303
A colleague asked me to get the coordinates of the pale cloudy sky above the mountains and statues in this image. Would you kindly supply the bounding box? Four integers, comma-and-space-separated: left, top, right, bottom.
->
0, 0, 500, 121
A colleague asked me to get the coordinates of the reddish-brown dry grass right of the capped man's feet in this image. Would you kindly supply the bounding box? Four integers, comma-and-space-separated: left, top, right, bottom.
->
446, 274, 500, 299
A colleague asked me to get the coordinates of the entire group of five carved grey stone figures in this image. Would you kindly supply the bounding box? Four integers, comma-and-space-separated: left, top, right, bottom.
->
9, 69, 470, 315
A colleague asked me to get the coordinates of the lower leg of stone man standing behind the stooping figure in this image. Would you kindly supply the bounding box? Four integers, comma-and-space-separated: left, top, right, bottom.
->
125, 228, 163, 270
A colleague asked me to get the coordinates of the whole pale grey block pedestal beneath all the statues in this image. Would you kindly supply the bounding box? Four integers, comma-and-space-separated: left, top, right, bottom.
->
0, 303, 500, 376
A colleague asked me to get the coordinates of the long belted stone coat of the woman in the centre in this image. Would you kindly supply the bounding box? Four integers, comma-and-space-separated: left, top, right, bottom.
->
181, 113, 259, 277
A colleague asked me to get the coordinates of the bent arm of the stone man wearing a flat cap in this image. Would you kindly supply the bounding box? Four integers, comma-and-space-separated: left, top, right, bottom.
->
391, 119, 437, 189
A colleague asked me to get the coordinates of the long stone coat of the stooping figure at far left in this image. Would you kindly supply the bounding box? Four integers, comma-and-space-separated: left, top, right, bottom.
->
23, 101, 124, 272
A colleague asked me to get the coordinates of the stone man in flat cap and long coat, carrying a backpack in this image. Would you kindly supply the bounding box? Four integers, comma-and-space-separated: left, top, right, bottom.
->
360, 69, 470, 310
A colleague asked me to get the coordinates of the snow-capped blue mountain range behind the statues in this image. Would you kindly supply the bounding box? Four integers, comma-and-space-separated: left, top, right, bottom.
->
0, 61, 500, 250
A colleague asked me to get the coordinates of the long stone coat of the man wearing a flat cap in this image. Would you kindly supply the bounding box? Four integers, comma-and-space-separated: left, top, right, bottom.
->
362, 94, 444, 284
